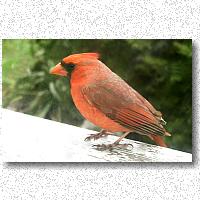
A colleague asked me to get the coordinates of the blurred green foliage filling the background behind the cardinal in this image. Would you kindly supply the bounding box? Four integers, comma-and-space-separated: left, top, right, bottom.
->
3, 40, 192, 152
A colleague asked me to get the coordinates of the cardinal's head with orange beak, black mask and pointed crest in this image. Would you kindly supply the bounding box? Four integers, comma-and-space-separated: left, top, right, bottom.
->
50, 53, 99, 76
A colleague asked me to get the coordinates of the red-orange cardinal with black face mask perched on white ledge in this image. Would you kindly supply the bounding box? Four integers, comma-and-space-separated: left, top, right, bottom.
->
50, 53, 170, 148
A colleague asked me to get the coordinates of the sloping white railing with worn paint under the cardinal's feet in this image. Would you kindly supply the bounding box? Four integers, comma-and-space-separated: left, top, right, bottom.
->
1, 109, 192, 162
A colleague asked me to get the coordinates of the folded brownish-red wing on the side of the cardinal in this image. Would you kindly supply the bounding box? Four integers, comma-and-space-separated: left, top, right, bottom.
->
82, 81, 166, 135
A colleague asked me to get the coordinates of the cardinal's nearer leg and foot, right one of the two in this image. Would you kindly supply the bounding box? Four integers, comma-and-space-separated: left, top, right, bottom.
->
93, 132, 133, 150
